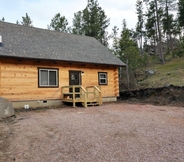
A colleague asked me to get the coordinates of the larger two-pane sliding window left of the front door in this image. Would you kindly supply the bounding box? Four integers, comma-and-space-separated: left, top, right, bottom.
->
38, 68, 59, 87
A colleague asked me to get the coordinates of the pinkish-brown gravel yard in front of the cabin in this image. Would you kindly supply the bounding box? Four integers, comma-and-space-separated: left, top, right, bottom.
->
0, 103, 184, 162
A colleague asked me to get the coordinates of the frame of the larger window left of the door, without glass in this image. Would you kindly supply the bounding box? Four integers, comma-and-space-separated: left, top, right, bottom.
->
38, 68, 59, 88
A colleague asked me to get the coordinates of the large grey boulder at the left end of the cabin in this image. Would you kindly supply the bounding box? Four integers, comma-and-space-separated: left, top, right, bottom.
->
0, 97, 15, 118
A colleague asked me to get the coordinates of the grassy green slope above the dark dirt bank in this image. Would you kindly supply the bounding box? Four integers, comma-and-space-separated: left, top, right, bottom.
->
137, 58, 184, 88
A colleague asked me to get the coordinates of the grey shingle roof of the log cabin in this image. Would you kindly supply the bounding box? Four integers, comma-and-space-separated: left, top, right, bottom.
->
0, 21, 125, 66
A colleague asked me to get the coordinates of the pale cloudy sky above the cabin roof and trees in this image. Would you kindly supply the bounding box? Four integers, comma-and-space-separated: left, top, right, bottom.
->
0, 0, 137, 33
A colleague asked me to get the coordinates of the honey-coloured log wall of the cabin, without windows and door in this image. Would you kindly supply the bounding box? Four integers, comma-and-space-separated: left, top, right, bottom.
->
0, 58, 119, 107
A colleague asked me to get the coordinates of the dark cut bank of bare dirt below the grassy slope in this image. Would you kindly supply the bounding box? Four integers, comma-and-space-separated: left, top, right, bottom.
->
119, 85, 184, 107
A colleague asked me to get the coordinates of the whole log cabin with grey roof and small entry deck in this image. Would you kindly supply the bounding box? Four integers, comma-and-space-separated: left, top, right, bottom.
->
0, 21, 125, 108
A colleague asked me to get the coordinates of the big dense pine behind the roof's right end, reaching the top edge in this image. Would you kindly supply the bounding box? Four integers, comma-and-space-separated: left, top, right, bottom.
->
72, 0, 110, 46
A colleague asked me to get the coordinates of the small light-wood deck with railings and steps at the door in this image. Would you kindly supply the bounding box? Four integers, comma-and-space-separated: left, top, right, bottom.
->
61, 85, 102, 107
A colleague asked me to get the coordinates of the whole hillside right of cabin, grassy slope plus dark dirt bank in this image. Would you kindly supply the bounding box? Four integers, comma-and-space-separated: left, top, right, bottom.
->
119, 58, 184, 107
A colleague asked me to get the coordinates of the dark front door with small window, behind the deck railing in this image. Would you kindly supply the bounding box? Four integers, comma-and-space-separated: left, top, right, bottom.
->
69, 71, 81, 97
